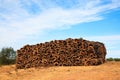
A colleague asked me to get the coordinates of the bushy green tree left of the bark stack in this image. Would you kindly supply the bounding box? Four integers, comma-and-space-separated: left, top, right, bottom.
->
0, 47, 16, 65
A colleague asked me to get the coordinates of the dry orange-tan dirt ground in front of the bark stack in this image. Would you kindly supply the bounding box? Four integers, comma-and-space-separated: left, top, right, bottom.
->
0, 62, 120, 80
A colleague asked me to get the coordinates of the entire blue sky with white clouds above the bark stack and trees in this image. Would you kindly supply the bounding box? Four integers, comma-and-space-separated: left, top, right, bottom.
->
0, 0, 120, 58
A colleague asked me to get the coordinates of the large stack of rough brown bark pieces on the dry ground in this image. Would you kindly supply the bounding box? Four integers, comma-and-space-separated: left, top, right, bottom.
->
16, 38, 106, 69
